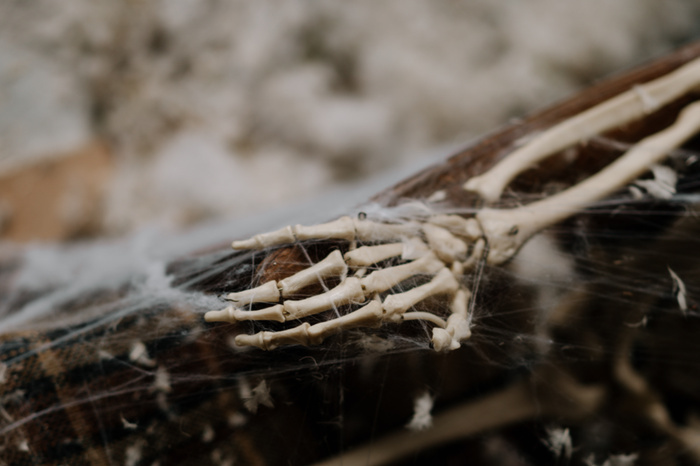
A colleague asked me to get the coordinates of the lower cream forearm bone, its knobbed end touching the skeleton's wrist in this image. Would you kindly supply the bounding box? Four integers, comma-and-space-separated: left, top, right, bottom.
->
476, 102, 700, 264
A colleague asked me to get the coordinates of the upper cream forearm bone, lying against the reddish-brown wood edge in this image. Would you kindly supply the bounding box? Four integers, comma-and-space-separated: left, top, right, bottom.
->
464, 55, 700, 202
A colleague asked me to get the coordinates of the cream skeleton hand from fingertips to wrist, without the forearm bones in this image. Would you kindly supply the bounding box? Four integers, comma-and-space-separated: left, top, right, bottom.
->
205, 216, 484, 350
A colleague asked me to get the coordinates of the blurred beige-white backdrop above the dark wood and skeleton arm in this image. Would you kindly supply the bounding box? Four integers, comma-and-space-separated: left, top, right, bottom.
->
0, 0, 700, 240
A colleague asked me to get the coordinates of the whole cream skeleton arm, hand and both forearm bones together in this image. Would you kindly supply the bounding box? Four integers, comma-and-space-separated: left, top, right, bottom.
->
205, 55, 700, 351
